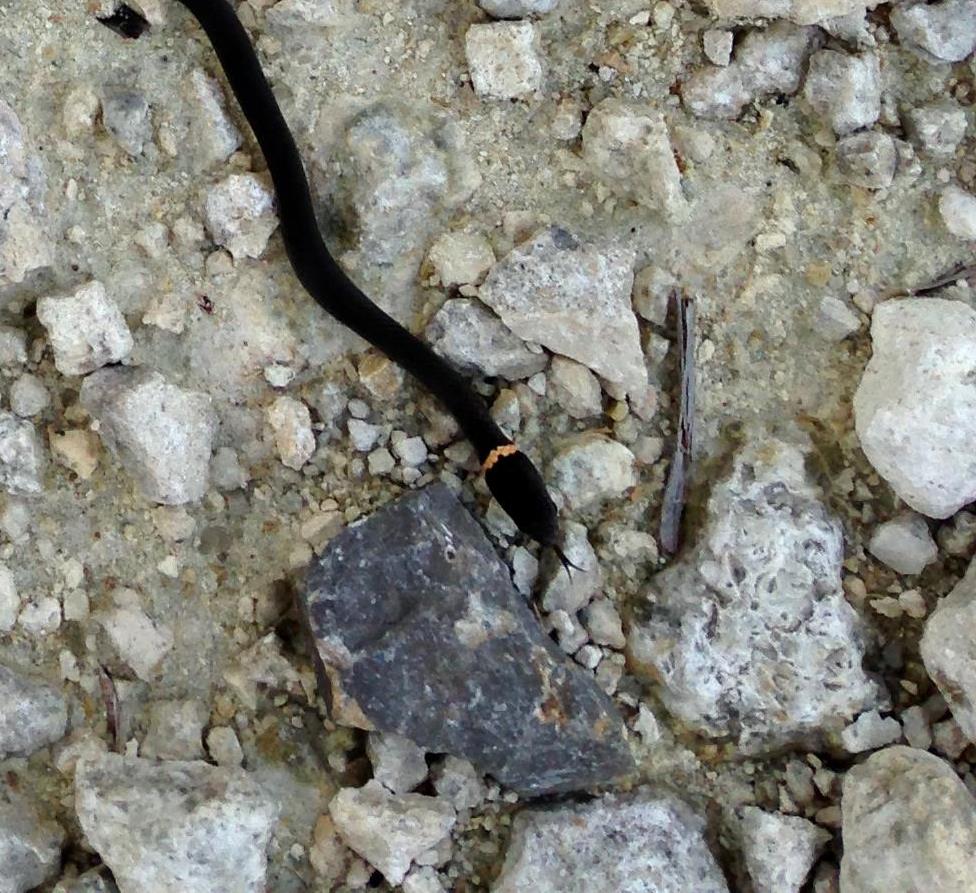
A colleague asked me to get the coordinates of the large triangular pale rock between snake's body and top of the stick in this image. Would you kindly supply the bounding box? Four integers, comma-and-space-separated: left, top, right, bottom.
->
480, 227, 647, 396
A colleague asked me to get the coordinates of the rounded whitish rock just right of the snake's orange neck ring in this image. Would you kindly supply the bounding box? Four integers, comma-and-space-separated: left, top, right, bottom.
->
552, 434, 637, 509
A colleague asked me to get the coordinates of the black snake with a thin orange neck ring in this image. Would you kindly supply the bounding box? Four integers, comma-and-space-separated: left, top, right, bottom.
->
173, 0, 558, 547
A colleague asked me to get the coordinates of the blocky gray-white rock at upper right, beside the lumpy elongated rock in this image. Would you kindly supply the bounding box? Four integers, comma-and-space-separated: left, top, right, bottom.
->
803, 50, 881, 136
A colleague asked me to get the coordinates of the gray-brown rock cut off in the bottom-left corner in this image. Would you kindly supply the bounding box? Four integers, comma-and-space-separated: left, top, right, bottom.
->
0, 784, 64, 893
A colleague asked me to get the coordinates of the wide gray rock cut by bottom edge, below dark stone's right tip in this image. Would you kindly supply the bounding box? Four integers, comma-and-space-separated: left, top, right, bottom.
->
491, 794, 728, 893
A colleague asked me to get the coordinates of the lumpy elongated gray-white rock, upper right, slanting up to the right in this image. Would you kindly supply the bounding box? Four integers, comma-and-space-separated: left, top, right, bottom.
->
681, 22, 819, 118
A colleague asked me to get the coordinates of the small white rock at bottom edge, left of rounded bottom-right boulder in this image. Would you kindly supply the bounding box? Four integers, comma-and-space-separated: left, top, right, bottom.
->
740, 806, 830, 893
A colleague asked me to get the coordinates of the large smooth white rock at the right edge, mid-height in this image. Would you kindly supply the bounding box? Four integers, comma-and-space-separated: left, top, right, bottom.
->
854, 298, 976, 518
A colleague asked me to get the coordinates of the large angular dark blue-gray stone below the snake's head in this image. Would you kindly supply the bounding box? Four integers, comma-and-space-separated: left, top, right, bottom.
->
303, 484, 634, 795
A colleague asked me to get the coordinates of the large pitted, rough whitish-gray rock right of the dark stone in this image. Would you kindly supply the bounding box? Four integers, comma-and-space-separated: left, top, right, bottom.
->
628, 440, 879, 751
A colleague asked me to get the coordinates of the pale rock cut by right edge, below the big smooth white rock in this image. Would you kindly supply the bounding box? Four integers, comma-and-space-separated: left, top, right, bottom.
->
920, 560, 976, 743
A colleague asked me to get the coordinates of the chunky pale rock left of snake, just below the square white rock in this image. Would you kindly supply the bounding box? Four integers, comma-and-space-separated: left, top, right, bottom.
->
80, 368, 217, 505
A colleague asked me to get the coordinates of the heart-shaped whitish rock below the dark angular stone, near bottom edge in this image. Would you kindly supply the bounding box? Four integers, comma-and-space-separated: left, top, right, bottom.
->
329, 780, 456, 885
